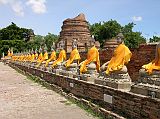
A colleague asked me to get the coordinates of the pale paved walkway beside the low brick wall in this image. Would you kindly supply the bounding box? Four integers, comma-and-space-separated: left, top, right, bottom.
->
0, 63, 95, 119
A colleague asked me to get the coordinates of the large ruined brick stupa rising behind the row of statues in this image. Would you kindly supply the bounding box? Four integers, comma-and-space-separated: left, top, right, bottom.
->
57, 14, 99, 52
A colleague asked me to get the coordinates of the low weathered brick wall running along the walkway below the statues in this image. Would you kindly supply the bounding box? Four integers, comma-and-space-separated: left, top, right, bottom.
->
11, 64, 160, 119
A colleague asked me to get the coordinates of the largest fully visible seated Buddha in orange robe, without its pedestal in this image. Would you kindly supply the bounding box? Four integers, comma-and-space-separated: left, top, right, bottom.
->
101, 33, 132, 79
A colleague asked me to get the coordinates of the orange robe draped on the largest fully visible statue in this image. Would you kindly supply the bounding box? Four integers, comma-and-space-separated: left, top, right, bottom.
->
106, 44, 132, 74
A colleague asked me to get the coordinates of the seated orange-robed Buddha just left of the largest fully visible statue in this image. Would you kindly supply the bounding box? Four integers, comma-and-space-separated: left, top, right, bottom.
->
80, 41, 100, 74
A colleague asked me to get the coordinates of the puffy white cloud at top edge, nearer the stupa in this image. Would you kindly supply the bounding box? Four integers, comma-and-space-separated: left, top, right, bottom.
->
26, 0, 46, 14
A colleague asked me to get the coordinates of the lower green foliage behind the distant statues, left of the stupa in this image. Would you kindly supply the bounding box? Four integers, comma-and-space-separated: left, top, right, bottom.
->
0, 33, 59, 57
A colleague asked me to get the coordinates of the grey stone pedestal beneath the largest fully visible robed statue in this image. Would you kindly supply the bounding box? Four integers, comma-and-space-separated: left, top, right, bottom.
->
95, 72, 132, 91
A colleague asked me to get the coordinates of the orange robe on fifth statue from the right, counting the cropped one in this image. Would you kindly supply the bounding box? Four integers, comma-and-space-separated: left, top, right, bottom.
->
52, 50, 66, 67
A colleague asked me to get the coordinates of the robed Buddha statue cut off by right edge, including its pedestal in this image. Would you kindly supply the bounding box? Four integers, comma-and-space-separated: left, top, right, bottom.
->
131, 42, 160, 98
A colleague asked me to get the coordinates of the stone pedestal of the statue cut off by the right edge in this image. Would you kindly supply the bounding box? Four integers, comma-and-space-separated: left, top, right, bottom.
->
131, 69, 160, 98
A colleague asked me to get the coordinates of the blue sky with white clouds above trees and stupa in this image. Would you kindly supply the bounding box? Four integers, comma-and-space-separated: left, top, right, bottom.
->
0, 0, 160, 38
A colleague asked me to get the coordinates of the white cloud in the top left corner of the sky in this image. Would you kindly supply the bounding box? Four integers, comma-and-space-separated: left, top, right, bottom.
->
0, 0, 24, 16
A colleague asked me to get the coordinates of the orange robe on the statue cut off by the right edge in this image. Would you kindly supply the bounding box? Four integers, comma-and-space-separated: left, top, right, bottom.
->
142, 48, 160, 74
